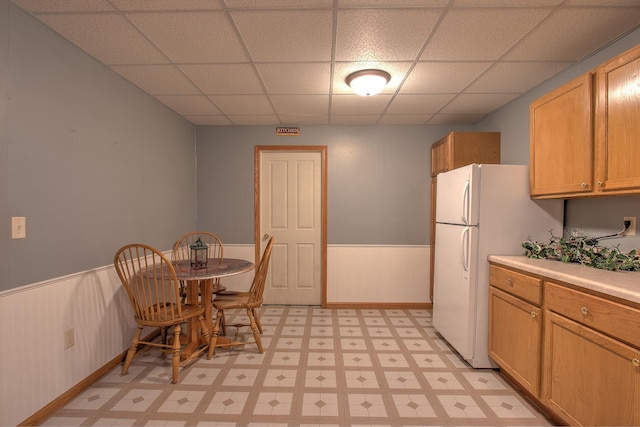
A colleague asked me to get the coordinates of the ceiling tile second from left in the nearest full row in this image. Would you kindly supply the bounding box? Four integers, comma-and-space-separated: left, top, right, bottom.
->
127, 12, 248, 64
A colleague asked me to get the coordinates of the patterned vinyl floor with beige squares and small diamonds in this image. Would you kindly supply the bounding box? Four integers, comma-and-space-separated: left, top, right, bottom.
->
42, 306, 553, 426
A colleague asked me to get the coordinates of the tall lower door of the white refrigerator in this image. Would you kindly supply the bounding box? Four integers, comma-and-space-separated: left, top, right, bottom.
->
433, 224, 478, 360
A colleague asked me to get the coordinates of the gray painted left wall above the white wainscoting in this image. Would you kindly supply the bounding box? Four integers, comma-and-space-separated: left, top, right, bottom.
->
0, 0, 196, 290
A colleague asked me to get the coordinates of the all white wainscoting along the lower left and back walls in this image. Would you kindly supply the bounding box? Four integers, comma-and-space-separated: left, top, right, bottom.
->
0, 245, 429, 426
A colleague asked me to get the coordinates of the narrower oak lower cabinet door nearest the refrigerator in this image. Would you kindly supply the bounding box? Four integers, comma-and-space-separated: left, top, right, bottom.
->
489, 286, 542, 397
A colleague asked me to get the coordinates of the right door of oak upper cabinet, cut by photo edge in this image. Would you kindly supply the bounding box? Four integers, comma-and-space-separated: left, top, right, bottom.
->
595, 42, 640, 194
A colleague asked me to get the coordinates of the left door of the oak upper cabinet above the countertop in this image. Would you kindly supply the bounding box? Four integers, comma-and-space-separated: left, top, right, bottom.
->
529, 73, 593, 198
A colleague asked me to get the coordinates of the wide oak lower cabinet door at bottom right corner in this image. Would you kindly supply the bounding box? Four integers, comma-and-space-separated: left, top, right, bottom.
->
543, 311, 640, 426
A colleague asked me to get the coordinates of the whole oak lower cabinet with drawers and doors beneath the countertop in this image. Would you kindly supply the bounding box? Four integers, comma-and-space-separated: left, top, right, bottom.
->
489, 264, 640, 426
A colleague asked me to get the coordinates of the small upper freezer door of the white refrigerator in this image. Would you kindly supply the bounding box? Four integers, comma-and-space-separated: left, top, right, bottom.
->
436, 165, 480, 225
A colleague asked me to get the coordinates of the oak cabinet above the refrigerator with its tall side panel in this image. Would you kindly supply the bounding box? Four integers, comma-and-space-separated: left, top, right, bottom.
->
429, 132, 500, 302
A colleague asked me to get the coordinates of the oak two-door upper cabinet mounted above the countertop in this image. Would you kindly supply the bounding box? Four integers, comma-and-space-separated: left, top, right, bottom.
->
529, 41, 640, 198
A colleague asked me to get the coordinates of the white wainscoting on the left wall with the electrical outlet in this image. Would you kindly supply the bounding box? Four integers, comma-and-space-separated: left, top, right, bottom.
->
0, 266, 135, 425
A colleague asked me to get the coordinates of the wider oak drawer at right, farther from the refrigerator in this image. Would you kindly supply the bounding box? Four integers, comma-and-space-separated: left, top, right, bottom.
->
544, 282, 640, 347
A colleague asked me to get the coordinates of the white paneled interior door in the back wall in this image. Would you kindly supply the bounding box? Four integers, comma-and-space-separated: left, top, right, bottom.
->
260, 151, 323, 305
